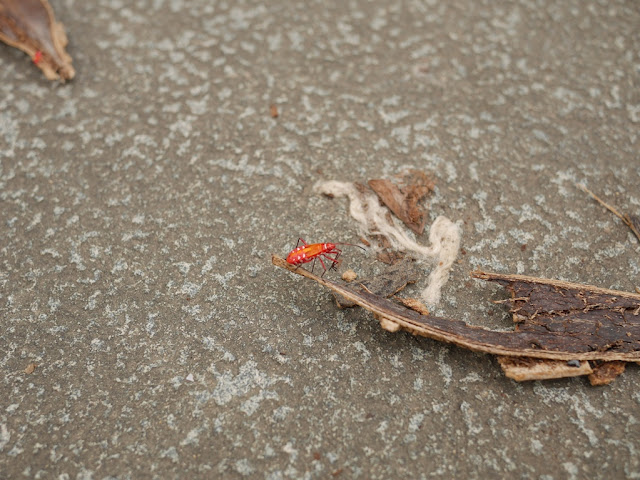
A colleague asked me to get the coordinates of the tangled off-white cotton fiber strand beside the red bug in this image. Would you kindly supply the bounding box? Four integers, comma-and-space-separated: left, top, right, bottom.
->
314, 180, 460, 306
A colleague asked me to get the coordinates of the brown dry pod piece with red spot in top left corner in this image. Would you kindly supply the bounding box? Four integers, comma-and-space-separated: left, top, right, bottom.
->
0, 0, 76, 82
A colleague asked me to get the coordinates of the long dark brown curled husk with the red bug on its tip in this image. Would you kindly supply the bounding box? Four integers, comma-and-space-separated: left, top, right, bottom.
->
272, 255, 640, 380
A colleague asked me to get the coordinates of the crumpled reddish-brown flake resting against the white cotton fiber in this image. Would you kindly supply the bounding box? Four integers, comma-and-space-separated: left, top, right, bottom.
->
368, 170, 435, 235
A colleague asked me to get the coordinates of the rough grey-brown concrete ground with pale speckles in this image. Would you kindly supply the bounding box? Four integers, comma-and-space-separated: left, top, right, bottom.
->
0, 0, 640, 480
